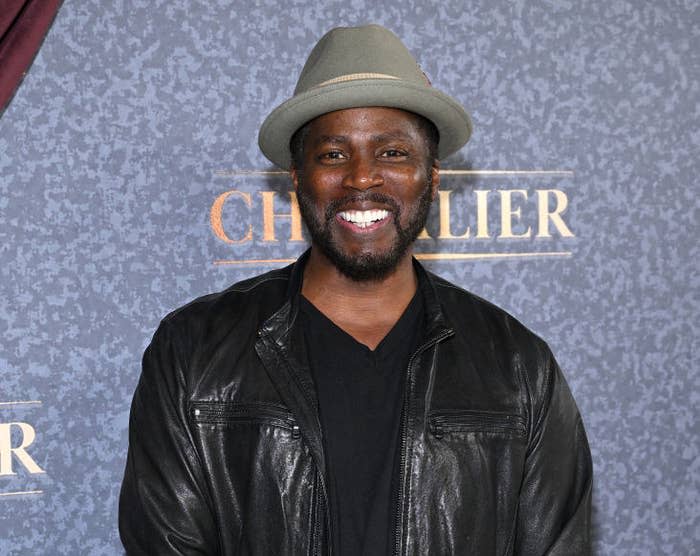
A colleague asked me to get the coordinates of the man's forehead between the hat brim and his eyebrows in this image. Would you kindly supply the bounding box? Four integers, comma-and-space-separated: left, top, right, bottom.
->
308, 106, 422, 139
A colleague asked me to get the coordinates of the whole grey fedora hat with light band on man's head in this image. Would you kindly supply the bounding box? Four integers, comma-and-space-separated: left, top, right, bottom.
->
258, 25, 472, 168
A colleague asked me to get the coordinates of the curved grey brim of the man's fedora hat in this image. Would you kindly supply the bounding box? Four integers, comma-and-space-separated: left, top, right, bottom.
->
258, 79, 472, 169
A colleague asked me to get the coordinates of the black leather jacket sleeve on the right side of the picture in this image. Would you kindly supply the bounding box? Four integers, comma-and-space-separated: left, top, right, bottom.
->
514, 348, 593, 556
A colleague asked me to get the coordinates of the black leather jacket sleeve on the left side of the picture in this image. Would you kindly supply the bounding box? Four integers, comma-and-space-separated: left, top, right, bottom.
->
119, 321, 219, 556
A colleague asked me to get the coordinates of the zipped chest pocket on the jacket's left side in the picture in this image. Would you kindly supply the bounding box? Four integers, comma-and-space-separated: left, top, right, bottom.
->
189, 402, 300, 438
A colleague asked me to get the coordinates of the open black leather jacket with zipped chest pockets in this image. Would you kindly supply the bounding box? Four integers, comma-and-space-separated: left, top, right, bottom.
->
119, 251, 591, 556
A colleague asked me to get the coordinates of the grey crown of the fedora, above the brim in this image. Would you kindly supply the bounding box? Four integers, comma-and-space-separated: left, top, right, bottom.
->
294, 24, 429, 95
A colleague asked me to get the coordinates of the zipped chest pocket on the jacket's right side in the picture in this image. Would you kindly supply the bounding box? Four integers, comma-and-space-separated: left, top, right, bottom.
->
428, 409, 527, 438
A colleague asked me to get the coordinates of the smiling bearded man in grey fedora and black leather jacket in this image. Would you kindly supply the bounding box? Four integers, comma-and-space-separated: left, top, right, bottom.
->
120, 25, 591, 556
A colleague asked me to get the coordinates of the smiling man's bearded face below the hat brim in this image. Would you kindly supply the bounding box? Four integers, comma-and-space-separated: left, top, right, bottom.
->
292, 107, 439, 281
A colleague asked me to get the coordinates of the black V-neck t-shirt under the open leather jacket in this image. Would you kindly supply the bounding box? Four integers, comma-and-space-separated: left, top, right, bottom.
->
300, 290, 424, 556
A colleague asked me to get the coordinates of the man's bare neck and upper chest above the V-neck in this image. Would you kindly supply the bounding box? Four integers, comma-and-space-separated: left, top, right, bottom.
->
301, 247, 418, 349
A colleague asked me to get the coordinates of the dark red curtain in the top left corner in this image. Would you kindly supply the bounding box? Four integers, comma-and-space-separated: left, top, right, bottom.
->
0, 0, 62, 115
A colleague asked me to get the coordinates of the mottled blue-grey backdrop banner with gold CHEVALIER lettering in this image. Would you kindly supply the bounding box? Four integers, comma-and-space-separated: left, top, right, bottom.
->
0, 0, 700, 555
